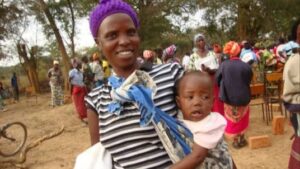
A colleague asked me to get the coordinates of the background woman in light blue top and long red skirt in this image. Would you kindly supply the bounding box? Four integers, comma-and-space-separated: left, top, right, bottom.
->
69, 59, 87, 123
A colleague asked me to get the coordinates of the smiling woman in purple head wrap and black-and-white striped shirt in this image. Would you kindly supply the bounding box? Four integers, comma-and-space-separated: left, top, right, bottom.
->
85, 0, 183, 169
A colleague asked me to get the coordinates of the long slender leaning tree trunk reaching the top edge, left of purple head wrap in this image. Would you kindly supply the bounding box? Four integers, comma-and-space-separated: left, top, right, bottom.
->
38, 0, 70, 92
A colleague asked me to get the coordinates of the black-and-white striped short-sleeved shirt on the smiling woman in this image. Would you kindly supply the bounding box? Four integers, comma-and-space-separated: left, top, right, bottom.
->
85, 63, 183, 169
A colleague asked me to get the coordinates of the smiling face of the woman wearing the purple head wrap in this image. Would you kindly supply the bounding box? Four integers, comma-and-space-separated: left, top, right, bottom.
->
97, 13, 140, 71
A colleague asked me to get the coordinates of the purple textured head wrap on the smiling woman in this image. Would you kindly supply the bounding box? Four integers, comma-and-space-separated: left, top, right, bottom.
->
90, 0, 139, 39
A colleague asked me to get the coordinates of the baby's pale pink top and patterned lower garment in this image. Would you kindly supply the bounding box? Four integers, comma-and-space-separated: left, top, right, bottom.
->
183, 112, 233, 169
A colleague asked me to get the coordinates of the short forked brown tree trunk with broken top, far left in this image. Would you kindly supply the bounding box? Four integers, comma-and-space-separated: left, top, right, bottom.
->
17, 44, 40, 93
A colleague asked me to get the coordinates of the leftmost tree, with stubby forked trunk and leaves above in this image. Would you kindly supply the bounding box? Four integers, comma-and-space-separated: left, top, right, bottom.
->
0, 0, 40, 92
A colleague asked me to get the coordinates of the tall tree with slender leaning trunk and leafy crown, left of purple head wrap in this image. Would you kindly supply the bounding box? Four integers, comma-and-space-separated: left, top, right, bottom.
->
30, 0, 99, 90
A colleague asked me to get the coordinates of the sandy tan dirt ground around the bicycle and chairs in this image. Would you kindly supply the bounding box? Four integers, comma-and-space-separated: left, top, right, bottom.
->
0, 94, 292, 169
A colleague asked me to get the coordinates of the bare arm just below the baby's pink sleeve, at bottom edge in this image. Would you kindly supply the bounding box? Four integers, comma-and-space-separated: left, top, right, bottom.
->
171, 143, 208, 169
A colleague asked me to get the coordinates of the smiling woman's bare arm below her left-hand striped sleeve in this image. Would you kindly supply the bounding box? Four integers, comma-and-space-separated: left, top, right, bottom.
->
87, 108, 100, 145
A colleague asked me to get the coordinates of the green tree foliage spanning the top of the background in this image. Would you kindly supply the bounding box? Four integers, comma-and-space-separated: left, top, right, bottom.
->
0, 0, 300, 68
